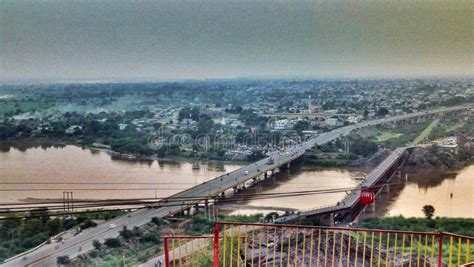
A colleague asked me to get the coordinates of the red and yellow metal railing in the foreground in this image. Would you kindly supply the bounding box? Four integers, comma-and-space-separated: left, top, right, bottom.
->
165, 222, 474, 267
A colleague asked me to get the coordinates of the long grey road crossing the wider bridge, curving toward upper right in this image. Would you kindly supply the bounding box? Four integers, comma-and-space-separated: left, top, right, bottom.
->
1, 104, 474, 266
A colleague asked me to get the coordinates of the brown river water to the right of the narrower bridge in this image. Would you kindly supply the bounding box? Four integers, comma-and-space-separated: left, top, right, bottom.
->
362, 165, 474, 218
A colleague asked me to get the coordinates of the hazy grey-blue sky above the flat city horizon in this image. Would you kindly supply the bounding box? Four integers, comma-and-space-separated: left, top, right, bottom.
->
0, 0, 474, 81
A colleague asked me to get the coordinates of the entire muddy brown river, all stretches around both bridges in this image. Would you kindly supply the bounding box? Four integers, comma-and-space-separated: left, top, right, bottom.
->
0, 144, 474, 217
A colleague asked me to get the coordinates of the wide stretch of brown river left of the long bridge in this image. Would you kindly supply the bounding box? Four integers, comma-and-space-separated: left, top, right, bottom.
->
0, 144, 240, 202
